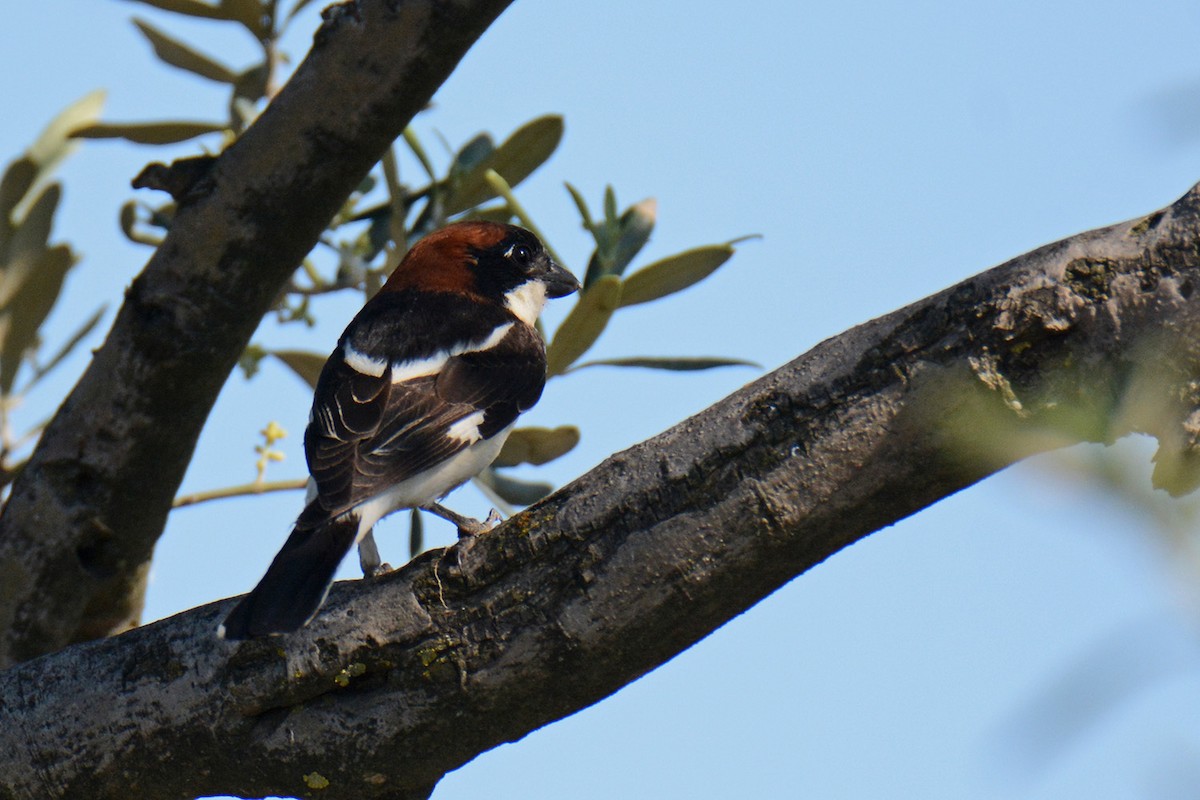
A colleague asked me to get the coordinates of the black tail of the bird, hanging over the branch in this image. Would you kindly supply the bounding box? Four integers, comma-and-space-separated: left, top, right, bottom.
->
217, 515, 359, 639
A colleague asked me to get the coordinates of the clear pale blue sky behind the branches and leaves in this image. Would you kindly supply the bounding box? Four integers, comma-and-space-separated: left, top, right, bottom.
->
0, 0, 1200, 800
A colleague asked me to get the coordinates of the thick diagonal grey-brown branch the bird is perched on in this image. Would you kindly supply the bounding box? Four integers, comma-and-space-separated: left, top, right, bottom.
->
0, 187, 1200, 799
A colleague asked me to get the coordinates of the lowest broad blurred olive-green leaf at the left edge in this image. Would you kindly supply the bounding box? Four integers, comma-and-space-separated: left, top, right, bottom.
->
0, 245, 78, 395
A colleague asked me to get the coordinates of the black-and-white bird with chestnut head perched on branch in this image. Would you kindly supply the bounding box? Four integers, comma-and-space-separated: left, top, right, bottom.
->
225, 219, 580, 640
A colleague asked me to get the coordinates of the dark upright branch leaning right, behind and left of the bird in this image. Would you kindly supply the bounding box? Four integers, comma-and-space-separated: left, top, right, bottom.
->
0, 0, 511, 666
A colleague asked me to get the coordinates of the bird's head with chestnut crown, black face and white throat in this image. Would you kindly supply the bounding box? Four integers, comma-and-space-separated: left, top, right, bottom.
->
382, 219, 580, 325
